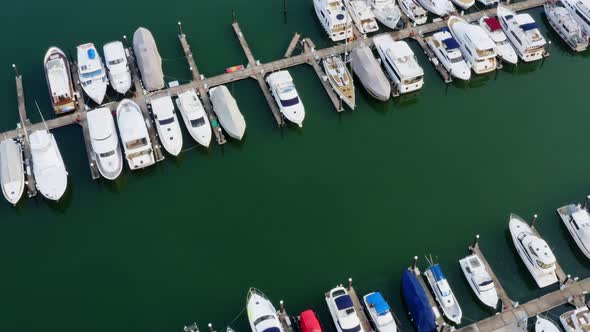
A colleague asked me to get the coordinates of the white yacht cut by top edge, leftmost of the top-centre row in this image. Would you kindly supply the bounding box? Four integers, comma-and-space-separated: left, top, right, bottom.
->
313, 0, 353, 42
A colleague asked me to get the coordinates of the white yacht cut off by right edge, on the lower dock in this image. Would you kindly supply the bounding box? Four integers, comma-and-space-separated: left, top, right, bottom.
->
557, 204, 590, 259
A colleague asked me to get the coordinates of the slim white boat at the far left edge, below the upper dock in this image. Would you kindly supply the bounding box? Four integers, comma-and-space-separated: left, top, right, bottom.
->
0, 139, 25, 205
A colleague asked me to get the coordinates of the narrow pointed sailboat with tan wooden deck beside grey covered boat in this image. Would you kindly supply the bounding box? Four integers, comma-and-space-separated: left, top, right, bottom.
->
322, 55, 355, 109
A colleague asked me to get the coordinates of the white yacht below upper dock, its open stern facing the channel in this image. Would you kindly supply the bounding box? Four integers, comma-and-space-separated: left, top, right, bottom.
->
117, 99, 156, 170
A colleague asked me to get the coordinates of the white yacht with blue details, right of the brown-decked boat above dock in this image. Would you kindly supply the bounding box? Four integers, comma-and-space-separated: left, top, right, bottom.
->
77, 43, 109, 105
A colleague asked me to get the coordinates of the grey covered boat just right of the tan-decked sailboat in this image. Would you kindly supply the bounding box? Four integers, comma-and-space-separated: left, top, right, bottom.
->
350, 44, 391, 101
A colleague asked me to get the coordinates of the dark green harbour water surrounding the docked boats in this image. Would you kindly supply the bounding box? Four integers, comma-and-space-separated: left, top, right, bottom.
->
0, 0, 590, 332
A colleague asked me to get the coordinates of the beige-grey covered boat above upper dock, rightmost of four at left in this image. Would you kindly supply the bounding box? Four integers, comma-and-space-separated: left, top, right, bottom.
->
133, 28, 164, 91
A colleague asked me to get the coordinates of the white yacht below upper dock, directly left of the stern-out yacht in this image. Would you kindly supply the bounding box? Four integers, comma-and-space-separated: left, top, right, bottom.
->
86, 107, 123, 180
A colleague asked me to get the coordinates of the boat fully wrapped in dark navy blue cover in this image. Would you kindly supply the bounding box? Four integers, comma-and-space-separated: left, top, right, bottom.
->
402, 270, 436, 332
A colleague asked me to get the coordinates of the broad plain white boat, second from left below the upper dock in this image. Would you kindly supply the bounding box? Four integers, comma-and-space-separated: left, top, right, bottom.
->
29, 129, 68, 201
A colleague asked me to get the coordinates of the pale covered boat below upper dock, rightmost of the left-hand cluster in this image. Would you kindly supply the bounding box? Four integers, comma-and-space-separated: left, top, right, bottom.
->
209, 85, 246, 140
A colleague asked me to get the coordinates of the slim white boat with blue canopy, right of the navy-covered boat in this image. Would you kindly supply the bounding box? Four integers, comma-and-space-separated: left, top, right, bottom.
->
424, 264, 463, 324
